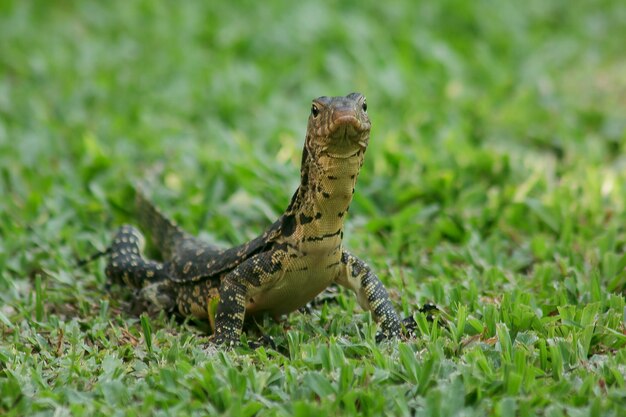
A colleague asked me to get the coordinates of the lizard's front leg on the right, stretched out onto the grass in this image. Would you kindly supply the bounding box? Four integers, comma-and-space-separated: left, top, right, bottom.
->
336, 250, 402, 337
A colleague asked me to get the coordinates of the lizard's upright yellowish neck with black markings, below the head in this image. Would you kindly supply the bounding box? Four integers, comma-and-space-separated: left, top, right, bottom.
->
285, 145, 365, 248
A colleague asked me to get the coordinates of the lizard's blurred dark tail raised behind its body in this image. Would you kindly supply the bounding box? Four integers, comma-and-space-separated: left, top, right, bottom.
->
135, 183, 185, 260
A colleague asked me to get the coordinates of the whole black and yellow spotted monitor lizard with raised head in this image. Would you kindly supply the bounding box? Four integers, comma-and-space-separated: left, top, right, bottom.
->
106, 93, 401, 345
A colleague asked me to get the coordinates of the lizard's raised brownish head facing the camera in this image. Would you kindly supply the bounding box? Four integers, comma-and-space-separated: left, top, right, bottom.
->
306, 93, 371, 158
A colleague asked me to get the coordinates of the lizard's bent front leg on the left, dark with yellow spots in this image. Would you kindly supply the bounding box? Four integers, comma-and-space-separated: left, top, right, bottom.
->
212, 250, 285, 346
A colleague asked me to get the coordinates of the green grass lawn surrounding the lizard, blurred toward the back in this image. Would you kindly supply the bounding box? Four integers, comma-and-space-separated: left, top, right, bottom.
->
0, 0, 626, 416
